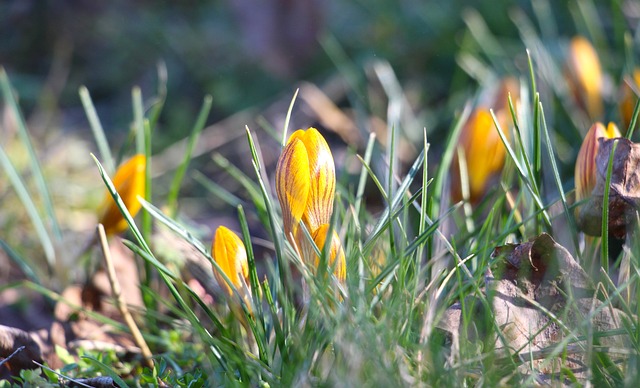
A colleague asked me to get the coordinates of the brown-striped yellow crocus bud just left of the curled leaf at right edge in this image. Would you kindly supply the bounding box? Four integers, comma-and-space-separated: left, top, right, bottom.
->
575, 123, 620, 206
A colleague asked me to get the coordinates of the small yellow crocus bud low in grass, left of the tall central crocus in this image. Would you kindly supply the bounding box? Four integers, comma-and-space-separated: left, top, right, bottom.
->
211, 226, 249, 298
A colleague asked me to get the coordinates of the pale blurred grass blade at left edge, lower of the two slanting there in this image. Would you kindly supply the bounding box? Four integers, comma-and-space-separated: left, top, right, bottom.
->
0, 146, 56, 270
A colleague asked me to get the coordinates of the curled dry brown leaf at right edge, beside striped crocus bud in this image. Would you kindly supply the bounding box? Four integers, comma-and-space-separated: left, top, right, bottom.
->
577, 138, 640, 239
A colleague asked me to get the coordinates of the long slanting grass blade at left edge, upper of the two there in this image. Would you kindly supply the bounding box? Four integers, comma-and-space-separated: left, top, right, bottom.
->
0, 66, 62, 241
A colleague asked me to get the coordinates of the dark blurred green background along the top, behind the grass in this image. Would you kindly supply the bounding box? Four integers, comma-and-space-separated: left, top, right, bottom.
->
0, 0, 604, 144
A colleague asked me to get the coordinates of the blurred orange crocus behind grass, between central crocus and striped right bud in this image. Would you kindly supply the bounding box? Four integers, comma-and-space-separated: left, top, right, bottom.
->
451, 109, 507, 203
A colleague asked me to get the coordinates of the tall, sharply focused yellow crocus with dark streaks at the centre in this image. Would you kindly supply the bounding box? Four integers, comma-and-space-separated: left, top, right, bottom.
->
276, 128, 345, 280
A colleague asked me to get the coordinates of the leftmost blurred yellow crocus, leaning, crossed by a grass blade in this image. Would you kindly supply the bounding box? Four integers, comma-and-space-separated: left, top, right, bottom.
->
99, 154, 147, 235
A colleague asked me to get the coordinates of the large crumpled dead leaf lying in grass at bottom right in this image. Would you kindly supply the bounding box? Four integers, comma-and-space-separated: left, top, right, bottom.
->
439, 234, 628, 384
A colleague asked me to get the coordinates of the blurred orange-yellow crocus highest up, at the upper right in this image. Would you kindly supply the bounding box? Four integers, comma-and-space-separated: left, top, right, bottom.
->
567, 36, 603, 119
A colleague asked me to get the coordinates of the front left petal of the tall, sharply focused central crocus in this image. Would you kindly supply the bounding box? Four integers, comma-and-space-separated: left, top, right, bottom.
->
276, 138, 311, 246
